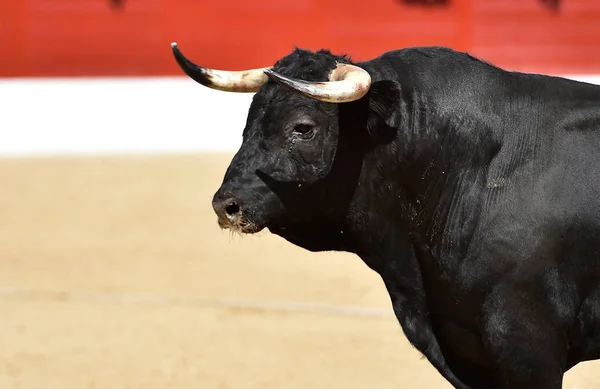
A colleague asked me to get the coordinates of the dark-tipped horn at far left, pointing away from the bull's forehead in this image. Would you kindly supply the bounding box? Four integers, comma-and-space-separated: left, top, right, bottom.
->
171, 42, 268, 92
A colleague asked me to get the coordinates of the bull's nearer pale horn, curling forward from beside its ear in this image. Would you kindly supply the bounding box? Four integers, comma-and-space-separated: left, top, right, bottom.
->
265, 64, 371, 103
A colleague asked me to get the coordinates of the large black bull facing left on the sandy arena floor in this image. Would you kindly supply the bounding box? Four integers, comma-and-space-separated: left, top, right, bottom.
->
174, 47, 600, 389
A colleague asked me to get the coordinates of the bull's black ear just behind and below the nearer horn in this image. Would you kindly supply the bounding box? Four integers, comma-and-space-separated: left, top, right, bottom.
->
367, 80, 402, 140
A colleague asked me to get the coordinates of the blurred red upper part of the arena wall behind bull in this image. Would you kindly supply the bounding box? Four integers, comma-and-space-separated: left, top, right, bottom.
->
0, 0, 600, 77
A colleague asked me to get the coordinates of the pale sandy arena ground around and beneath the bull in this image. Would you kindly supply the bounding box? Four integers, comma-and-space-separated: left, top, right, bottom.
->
0, 155, 600, 389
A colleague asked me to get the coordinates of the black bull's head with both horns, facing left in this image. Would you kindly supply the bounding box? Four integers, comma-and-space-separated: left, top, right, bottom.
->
172, 43, 400, 249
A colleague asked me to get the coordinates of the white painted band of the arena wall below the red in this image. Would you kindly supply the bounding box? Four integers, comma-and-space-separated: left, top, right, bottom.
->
0, 76, 600, 156
